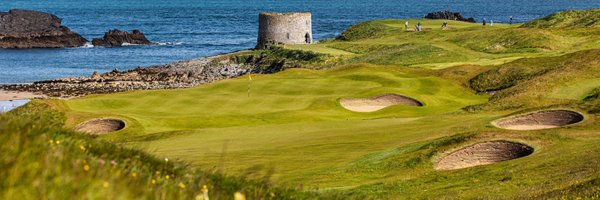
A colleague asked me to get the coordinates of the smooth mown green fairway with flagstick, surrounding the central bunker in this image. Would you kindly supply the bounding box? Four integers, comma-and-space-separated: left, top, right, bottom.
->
62, 66, 486, 186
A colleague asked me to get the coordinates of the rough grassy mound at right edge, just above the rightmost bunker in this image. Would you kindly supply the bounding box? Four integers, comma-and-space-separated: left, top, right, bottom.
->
470, 49, 600, 110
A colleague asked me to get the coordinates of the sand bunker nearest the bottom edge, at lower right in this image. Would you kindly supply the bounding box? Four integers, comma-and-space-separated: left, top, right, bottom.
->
435, 141, 533, 170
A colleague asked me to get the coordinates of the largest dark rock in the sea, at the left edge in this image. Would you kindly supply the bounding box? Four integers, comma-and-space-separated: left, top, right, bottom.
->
0, 9, 87, 48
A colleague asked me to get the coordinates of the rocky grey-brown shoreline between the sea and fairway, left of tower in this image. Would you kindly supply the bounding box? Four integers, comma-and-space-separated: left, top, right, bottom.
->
0, 51, 287, 98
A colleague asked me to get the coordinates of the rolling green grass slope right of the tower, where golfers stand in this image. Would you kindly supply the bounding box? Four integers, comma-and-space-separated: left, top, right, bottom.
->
284, 14, 600, 69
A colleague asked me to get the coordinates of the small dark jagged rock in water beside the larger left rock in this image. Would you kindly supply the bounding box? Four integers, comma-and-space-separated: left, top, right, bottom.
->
92, 29, 151, 47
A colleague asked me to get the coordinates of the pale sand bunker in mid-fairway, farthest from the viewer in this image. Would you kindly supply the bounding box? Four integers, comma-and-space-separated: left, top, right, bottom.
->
340, 94, 423, 112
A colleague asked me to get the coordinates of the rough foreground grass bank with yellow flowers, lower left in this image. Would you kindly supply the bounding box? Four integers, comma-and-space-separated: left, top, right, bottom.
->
0, 102, 338, 199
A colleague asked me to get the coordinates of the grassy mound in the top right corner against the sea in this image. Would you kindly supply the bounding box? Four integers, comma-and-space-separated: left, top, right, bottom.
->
522, 9, 600, 28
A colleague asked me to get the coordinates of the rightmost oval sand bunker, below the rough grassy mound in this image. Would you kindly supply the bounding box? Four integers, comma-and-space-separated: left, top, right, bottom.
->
493, 110, 584, 130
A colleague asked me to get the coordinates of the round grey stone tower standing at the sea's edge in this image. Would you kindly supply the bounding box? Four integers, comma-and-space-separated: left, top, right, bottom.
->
256, 12, 313, 49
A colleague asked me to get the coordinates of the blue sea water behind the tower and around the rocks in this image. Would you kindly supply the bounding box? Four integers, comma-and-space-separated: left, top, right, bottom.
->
0, 0, 600, 83
